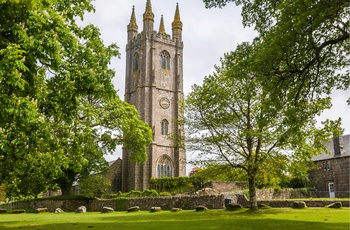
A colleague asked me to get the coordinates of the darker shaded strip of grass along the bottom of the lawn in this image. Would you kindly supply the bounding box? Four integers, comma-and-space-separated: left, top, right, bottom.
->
0, 219, 349, 230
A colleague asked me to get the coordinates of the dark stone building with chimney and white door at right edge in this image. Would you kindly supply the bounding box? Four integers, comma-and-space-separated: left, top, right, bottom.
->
310, 134, 350, 198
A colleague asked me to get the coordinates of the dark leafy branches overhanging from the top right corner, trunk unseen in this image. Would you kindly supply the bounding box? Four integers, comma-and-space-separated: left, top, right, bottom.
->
203, 0, 350, 103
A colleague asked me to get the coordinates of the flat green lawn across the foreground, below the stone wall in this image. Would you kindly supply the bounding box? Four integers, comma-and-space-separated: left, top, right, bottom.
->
0, 208, 350, 230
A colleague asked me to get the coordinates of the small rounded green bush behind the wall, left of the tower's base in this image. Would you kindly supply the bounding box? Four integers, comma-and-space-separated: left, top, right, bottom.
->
79, 175, 111, 198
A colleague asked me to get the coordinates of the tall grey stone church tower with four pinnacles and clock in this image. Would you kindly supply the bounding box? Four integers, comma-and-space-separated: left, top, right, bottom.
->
122, 0, 186, 191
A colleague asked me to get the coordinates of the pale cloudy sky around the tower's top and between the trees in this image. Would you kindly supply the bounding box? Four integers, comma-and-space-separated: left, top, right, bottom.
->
83, 0, 350, 165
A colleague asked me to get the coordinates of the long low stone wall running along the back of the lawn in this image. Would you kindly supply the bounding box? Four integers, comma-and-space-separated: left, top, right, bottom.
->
0, 193, 350, 212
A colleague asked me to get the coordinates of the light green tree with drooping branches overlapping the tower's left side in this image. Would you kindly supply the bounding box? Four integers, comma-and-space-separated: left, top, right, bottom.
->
56, 97, 152, 195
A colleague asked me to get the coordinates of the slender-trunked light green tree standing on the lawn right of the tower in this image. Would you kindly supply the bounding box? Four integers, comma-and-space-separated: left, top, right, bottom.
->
185, 43, 330, 210
